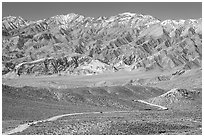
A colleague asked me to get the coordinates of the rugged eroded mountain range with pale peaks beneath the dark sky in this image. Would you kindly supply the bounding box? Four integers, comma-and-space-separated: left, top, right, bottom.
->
2, 13, 202, 75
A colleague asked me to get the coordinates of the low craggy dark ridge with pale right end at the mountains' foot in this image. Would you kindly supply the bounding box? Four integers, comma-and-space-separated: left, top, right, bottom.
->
12, 55, 111, 75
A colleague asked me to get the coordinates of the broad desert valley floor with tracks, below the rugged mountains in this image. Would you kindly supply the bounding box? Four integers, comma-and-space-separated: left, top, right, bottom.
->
2, 69, 202, 135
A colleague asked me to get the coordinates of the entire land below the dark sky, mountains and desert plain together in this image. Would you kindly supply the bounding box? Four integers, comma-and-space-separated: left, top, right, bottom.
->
2, 2, 202, 135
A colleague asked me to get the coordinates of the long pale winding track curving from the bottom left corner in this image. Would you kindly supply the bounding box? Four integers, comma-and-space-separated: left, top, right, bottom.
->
3, 111, 135, 135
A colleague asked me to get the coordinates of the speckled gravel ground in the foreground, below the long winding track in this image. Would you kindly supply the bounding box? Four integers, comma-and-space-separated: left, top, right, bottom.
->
15, 110, 202, 135
